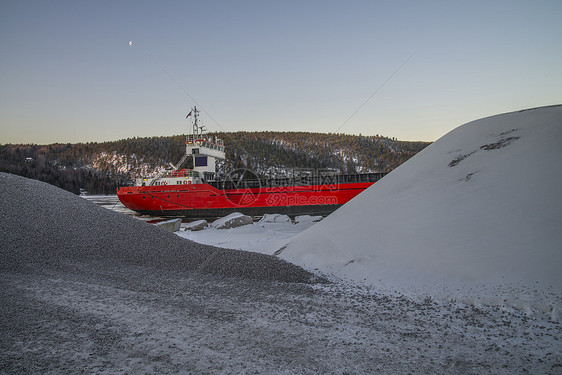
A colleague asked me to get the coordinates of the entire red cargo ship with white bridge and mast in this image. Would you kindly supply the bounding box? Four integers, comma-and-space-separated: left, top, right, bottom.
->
117, 107, 385, 218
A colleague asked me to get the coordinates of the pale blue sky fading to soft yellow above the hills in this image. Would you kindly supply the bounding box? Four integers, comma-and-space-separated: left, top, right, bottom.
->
0, 0, 562, 144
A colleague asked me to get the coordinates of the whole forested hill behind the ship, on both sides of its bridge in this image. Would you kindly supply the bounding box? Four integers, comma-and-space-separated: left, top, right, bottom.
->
0, 132, 429, 194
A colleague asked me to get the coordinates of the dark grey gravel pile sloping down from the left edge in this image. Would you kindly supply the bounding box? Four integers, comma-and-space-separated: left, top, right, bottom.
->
0, 173, 314, 283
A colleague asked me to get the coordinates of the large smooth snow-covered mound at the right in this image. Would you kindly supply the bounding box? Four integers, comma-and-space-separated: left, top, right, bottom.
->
278, 106, 562, 306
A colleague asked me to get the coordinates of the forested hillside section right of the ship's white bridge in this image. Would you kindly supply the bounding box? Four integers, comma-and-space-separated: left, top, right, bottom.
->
218, 132, 428, 173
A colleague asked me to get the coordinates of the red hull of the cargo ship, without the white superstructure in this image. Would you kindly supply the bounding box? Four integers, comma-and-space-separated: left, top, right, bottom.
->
117, 174, 382, 218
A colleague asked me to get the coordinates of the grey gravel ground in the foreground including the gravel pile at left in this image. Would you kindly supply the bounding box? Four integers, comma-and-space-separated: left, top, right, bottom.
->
0, 174, 562, 374
